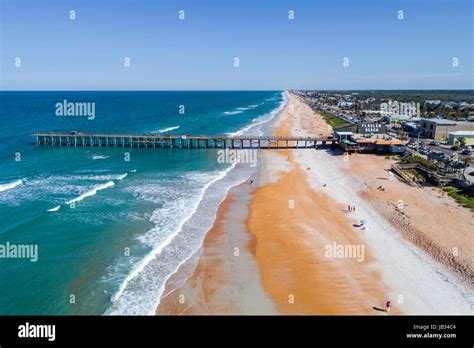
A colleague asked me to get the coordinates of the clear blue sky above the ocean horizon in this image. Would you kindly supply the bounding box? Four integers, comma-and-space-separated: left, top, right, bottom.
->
0, 0, 474, 90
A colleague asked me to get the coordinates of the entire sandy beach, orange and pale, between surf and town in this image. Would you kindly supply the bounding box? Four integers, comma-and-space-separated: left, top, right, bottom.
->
157, 93, 473, 315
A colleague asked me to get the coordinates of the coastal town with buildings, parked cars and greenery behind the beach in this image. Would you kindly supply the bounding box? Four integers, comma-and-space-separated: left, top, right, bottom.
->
294, 91, 474, 208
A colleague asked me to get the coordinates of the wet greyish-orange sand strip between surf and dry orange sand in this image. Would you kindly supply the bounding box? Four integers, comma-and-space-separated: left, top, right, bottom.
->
157, 173, 277, 315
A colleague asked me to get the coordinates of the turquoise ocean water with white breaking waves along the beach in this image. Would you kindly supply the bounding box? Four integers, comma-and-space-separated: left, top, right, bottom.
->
0, 91, 285, 315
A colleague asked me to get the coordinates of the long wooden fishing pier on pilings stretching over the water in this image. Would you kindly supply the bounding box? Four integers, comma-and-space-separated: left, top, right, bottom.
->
33, 133, 336, 149
